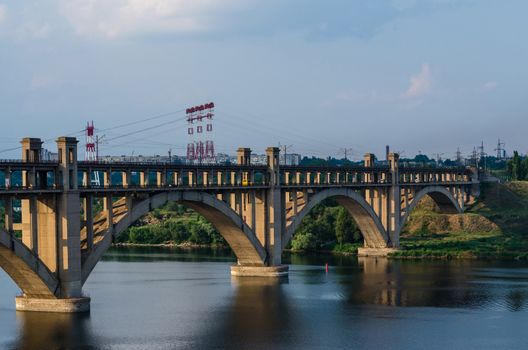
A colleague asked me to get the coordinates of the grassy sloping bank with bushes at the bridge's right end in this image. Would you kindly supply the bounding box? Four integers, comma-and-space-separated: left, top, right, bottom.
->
392, 182, 528, 259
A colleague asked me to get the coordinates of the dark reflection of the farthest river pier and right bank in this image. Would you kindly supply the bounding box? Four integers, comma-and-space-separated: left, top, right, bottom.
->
336, 258, 528, 311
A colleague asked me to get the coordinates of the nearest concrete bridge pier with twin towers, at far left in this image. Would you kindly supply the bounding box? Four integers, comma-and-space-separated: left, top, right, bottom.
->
16, 137, 90, 312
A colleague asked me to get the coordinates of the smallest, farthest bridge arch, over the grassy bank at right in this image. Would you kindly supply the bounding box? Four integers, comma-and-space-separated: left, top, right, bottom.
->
399, 186, 464, 231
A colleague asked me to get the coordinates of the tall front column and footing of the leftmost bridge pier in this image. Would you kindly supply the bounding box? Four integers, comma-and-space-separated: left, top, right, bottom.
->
16, 137, 90, 312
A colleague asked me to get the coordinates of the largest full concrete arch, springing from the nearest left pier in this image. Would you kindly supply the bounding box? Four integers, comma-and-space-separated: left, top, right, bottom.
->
82, 191, 267, 284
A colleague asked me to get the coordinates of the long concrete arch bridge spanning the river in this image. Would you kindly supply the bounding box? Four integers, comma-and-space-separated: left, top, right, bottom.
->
0, 137, 479, 312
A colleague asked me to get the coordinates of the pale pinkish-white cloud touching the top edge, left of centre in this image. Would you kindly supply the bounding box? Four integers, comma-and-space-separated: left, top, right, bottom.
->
59, 0, 256, 38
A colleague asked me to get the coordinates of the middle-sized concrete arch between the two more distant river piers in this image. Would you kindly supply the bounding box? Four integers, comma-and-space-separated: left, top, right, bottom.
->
282, 188, 389, 248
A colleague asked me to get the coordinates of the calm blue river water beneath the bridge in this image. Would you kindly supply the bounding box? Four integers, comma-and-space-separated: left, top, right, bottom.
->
0, 248, 528, 349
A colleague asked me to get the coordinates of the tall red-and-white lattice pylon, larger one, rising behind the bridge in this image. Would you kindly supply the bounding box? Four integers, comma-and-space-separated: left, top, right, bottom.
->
186, 102, 216, 163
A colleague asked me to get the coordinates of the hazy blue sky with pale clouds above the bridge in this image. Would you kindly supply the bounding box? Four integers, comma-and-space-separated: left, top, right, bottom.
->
0, 0, 528, 158
